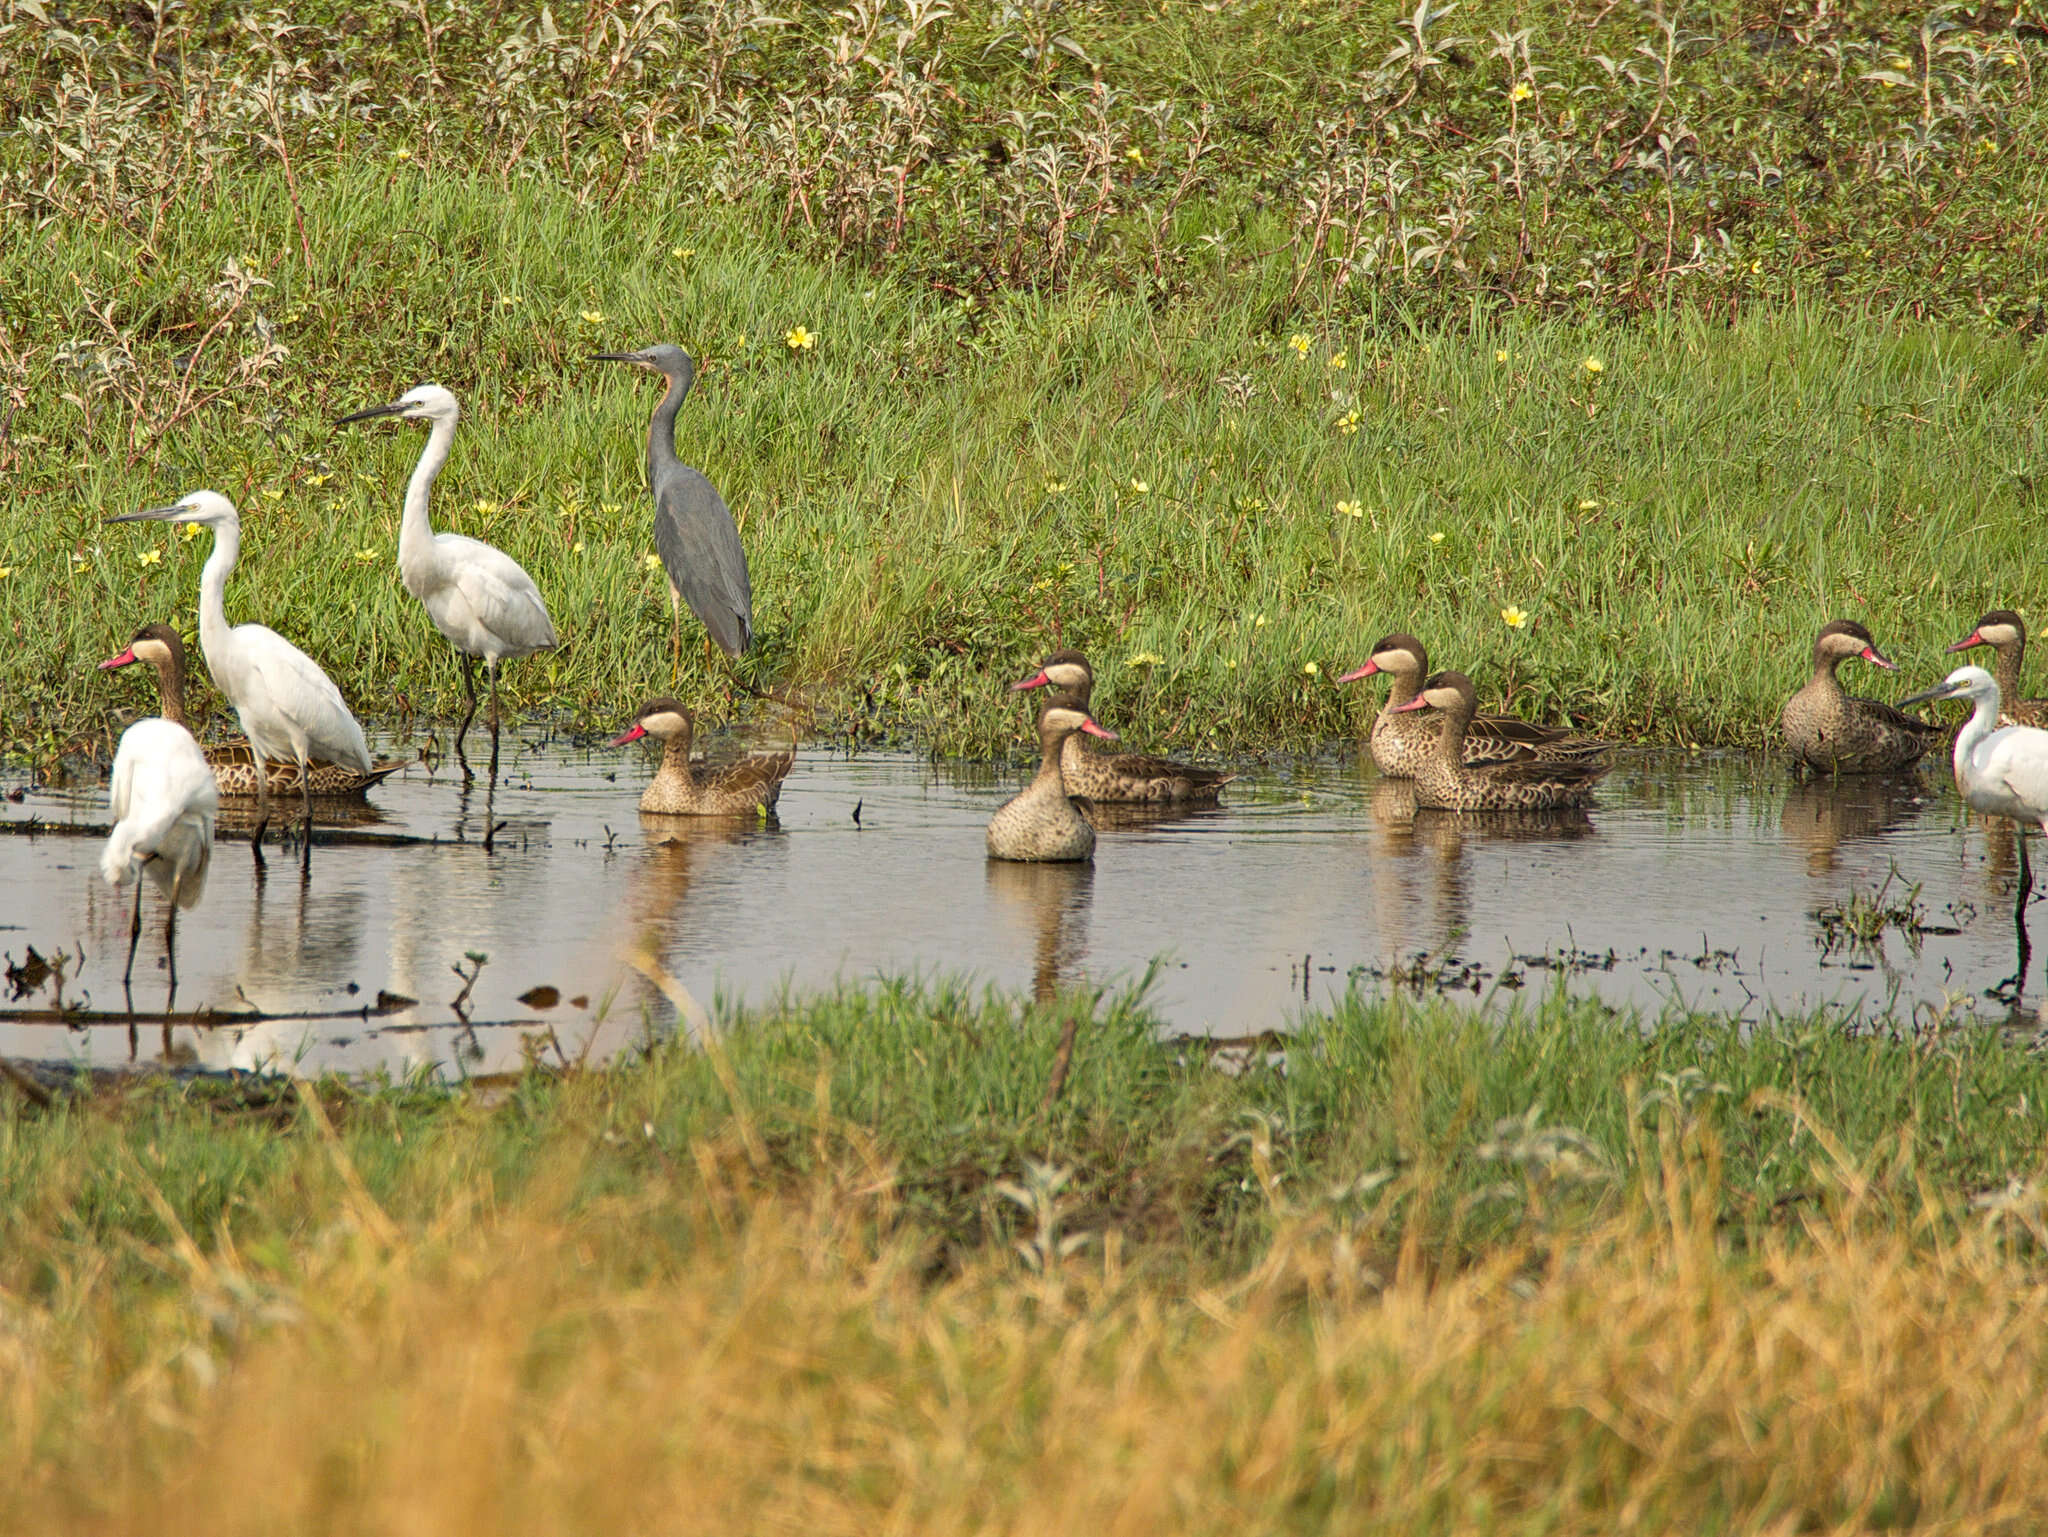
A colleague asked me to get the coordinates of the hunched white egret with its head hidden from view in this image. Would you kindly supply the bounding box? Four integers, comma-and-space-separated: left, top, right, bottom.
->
100, 715, 221, 994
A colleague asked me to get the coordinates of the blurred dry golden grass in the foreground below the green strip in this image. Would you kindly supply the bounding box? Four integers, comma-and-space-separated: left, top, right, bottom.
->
0, 1106, 2048, 1537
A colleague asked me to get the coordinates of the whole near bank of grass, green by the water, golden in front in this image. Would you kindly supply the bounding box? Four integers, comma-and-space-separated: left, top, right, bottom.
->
0, 988, 2048, 1533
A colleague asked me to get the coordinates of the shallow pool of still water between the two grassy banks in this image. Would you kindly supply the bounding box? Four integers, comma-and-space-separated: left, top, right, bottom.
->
0, 736, 2040, 1074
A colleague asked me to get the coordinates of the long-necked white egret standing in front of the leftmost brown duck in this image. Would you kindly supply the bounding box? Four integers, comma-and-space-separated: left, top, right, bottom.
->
109, 492, 377, 871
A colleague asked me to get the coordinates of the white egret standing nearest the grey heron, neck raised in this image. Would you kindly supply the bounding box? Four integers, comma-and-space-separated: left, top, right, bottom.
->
334, 385, 557, 779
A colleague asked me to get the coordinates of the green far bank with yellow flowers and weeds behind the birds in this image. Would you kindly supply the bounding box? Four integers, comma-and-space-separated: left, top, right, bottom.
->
0, 0, 2048, 762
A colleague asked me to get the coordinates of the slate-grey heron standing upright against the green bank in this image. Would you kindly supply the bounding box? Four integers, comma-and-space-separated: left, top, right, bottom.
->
598, 342, 754, 656
